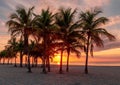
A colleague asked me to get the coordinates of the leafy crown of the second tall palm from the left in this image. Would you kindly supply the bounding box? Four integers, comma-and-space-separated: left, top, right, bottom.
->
34, 8, 55, 42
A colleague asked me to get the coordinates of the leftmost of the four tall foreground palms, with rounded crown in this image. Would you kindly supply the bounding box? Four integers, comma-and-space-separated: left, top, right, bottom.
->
6, 7, 34, 72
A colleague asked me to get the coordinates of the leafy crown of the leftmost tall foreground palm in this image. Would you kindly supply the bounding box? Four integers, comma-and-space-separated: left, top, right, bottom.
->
6, 7, 34, 36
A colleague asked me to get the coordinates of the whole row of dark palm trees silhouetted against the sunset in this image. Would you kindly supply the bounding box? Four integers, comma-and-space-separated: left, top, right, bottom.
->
0, 7, 115, 74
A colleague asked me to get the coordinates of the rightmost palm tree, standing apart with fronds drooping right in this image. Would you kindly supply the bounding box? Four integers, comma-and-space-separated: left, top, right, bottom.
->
80, 8, 115, 74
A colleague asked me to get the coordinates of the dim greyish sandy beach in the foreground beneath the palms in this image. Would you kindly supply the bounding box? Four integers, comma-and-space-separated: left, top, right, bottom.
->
0, 65, 120, 85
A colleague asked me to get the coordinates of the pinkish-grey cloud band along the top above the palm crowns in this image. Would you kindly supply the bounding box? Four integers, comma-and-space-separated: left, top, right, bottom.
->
1, 0, 110, 13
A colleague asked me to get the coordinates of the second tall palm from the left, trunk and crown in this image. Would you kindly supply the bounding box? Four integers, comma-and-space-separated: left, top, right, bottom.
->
35, 9, 54, 73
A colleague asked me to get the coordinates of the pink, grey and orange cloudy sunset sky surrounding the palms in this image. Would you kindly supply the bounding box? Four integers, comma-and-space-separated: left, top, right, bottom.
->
0, 0, 120, 65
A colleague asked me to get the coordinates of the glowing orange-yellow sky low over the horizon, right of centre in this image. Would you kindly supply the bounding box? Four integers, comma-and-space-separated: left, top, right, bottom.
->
54, 48, 120, 66
